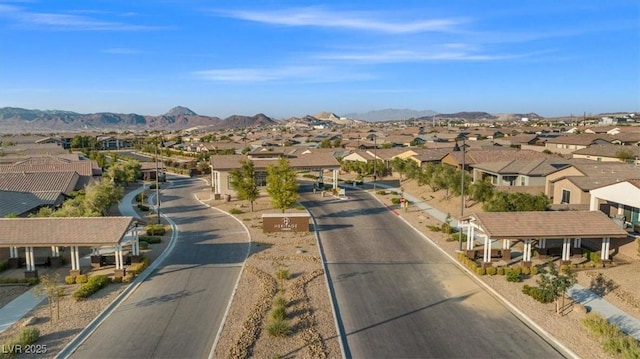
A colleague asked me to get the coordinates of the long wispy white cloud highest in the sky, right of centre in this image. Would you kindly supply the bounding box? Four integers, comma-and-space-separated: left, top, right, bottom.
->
216, 7, 466, 34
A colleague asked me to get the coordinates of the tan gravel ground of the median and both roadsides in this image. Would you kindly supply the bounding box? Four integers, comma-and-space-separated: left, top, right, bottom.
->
0, 181, 640, 358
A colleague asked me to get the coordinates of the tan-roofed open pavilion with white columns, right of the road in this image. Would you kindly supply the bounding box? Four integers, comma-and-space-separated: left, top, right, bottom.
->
463, 211, 628, 265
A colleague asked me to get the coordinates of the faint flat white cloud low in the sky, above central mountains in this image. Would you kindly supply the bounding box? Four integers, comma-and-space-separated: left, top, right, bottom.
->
192, 66, 373, 83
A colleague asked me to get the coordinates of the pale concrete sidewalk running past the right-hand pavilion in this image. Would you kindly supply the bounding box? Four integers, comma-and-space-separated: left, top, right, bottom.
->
368, 184, 640, 340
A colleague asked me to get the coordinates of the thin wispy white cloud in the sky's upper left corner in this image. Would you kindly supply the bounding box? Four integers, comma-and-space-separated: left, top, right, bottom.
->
0, 4, 164, 31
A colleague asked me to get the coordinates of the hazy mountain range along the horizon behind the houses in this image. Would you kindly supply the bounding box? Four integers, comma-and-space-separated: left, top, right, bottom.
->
0, 106, 556, 134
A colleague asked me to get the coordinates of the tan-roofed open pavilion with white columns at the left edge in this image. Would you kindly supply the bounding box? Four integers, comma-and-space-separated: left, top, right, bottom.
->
0, 217, 140, 278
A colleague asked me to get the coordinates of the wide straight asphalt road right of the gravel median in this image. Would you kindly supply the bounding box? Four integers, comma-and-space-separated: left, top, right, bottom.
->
303, 190, 563, 358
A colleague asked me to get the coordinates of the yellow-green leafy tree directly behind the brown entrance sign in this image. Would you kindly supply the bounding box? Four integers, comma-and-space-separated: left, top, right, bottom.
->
267, 158, 298, 213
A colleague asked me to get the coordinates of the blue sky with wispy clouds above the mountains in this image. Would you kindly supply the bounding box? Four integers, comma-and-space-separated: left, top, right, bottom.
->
0, 0, 640, 118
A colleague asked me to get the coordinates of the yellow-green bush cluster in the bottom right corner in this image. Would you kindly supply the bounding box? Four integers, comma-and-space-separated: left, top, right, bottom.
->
582, 312, 640, 358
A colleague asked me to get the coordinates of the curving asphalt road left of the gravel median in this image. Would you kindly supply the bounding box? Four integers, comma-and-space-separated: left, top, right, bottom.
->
72, 179, 249, 358
